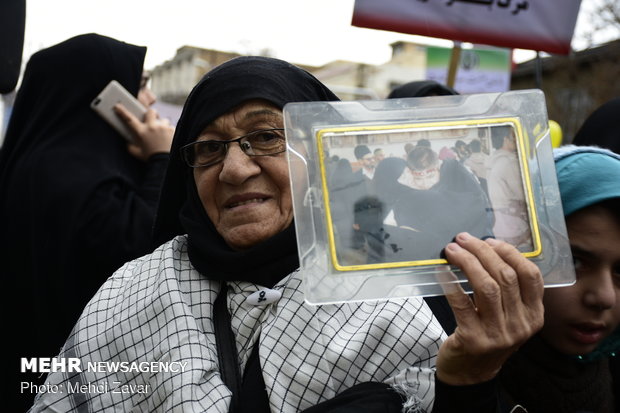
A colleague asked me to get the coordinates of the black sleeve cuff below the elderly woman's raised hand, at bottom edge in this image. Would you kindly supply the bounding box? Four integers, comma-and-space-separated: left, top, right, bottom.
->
433, 375, 500, 413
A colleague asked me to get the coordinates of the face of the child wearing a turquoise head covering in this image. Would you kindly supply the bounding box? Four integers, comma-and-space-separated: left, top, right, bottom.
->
541, 205, 620, 355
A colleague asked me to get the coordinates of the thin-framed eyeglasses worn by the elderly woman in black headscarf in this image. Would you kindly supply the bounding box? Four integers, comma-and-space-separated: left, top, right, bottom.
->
181, 128, 286, 168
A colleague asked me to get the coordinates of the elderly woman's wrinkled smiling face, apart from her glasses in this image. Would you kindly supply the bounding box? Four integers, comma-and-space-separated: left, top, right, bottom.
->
194, 100, 293, 250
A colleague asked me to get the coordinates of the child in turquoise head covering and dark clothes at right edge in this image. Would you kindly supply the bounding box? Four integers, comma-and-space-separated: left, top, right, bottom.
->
499, 146, 620, 413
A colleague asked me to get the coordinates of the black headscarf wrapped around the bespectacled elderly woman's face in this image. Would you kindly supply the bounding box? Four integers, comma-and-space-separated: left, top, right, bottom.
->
155, 57, 338, 286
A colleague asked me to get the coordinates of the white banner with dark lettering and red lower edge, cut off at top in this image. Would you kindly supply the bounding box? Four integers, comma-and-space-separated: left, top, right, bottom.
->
352, 0, 581, 54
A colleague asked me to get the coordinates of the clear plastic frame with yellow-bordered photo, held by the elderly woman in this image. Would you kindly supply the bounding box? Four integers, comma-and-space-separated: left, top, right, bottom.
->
284, 90, 575, 304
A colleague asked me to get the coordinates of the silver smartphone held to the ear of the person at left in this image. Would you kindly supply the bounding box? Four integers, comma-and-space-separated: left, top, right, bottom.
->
90, 80, 146, 143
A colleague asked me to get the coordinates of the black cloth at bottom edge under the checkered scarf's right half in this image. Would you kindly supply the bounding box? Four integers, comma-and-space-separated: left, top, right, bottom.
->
304, 382, 405, 413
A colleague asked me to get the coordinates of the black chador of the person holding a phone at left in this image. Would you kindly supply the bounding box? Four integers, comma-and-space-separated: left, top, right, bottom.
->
0, 34, 165, 408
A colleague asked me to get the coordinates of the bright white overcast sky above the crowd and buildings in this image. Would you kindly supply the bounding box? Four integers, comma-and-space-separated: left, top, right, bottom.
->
23, 0, 595, 69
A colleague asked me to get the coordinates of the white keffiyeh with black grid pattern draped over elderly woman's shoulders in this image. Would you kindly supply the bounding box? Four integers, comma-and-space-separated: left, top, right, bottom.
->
31, 236, 445, 413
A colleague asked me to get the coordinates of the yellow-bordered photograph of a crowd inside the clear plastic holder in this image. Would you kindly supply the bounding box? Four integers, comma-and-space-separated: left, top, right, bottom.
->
316, 118, 541, 271
